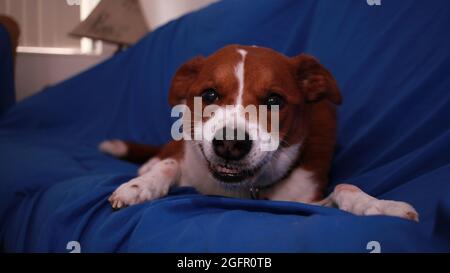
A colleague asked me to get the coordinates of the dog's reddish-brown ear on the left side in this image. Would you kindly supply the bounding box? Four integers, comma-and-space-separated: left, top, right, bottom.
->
169, 56, 205, 106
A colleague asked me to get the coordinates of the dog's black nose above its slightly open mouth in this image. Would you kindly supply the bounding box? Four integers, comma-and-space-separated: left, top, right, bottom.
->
212, 128, 253, 160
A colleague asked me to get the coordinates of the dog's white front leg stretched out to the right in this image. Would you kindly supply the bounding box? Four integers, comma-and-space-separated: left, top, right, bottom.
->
318, 184, 419, 222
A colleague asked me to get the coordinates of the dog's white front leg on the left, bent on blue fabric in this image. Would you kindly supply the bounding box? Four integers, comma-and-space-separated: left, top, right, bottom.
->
108, 158, 180, 209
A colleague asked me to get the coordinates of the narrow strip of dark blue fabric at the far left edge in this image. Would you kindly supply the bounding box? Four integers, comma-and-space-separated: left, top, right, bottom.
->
0, 25, 16, 115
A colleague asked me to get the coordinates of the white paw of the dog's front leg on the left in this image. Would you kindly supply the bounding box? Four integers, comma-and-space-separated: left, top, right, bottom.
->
108, 177, 169, 210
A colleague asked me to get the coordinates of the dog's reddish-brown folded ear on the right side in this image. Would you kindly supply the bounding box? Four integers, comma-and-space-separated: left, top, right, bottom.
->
291, 54, 342, 105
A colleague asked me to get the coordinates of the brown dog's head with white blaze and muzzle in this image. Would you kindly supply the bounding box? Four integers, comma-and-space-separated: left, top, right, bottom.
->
169, 45, 341, 187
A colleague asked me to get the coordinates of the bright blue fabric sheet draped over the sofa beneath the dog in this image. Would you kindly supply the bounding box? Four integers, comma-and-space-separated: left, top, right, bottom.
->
0, 0, 450, 252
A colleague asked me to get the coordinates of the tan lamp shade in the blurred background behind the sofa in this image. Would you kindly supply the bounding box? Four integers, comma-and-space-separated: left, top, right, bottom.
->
70, 0, 150, 45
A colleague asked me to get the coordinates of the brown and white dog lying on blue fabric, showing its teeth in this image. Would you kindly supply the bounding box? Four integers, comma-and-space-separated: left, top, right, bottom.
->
100, 45, 418, 221
